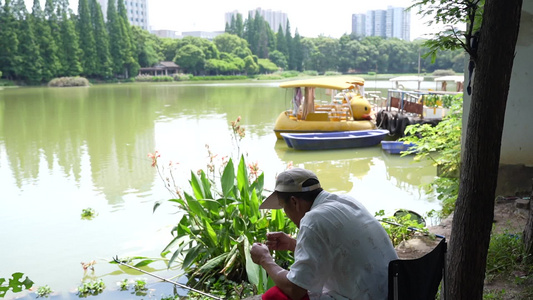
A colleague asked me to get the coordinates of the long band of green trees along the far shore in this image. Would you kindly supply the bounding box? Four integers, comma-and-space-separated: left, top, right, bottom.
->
0, 0, 464, 84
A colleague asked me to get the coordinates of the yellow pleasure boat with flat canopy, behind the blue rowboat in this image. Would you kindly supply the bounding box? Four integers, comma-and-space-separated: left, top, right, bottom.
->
274, 77, 376, 139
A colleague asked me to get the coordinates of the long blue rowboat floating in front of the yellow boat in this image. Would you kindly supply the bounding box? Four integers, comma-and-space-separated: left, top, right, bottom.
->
281, 129, 389, 150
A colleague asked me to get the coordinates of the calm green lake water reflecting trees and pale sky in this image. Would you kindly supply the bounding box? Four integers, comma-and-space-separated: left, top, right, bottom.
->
0, 82, 440, 299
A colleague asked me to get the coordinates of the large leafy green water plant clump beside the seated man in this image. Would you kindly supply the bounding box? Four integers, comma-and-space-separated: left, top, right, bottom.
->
154, 157, 296, 293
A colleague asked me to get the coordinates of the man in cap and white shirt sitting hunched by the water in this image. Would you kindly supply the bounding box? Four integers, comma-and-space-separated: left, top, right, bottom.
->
250, 168, 397, 300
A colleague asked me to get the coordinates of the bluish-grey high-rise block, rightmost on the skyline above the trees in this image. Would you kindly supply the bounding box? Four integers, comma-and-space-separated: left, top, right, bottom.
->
352, 6, 411, 41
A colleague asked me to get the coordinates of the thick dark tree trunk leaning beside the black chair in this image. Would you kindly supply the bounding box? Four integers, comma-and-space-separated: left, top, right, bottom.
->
446, 0, 522, 300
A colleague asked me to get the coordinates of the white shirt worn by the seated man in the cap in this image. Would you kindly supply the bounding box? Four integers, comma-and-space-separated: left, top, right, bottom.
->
287, 191, 398, 300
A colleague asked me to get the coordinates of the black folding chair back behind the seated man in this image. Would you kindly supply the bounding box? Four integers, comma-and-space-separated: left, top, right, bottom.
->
388, 238, 447, 300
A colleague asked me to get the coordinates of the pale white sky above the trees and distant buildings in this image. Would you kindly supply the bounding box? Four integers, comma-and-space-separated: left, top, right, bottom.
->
25, 0, 432, 40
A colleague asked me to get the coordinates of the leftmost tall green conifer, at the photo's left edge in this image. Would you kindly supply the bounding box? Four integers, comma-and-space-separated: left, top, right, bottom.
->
0, 0, 20, 79
